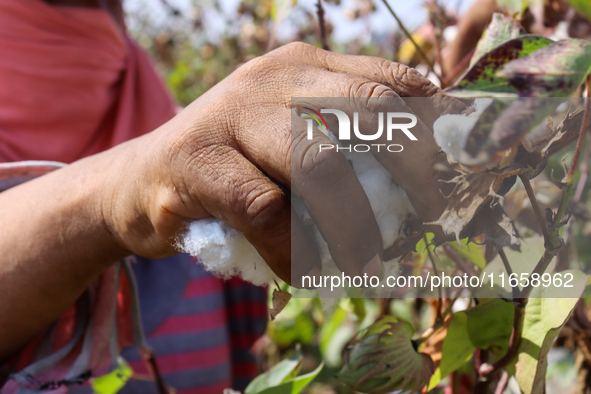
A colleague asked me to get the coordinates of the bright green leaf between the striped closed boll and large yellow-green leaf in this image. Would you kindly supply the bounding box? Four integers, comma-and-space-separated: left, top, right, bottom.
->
429, 298, 513, 390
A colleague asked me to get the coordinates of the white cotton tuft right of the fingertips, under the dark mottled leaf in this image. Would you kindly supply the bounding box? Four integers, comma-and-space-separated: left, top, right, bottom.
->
433, 98, 493, 162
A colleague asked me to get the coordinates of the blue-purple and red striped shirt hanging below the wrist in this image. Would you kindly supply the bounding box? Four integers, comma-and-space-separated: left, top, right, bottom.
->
121, 255, 268, 394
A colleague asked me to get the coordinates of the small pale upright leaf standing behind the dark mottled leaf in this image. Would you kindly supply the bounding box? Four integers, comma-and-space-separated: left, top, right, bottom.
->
470, 12, 526, 67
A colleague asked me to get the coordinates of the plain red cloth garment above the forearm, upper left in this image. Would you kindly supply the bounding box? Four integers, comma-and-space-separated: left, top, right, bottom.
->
0, 0, 175, 163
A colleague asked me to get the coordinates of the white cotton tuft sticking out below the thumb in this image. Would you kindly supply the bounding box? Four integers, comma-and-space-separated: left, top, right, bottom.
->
177, 219, 276, 286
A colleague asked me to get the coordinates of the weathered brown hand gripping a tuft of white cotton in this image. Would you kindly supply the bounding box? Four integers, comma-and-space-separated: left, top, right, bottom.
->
103, 43, 454, 282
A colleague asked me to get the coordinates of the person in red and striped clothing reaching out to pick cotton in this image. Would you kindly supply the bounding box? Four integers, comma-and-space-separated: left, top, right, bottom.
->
0, 0, 470, 394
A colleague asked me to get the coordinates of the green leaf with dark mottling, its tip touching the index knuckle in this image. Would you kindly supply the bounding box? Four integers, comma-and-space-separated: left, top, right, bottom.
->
446, 35, 552, 97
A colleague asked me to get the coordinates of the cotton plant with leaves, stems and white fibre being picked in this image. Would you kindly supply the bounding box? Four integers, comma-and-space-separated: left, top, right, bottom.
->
179, 10, 591, 394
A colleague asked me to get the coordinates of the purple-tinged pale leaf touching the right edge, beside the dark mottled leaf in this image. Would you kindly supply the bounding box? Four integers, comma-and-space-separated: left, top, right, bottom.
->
497, 39, 591, 97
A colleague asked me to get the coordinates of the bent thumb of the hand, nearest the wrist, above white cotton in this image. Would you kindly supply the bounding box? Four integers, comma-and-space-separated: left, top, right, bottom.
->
185, 145, 320, 284
